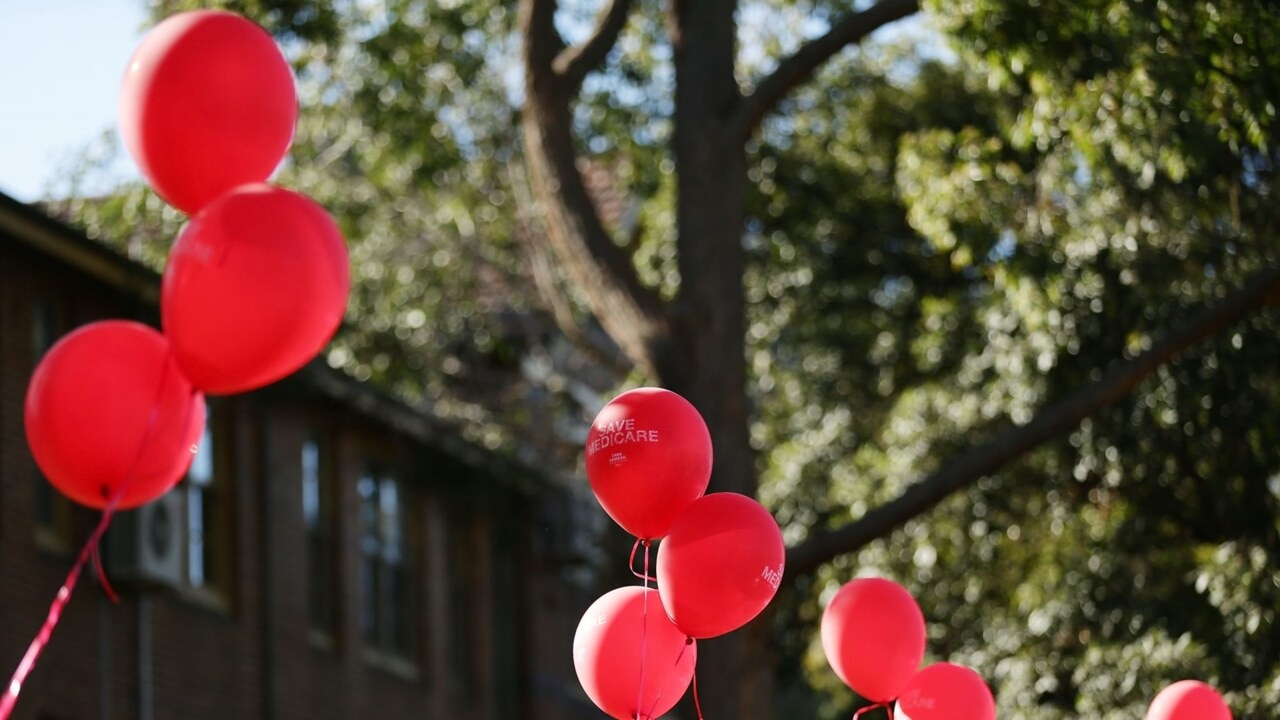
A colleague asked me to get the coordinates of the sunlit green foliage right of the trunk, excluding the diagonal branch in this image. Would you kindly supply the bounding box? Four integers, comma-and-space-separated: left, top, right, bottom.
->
756, 3, 1280, 717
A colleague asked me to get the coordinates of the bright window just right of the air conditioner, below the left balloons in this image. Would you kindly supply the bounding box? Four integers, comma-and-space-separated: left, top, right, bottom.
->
182, 410, 230, 605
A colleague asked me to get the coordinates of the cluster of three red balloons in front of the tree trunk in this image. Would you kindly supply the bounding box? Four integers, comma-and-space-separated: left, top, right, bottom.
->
573, 388, 786, 719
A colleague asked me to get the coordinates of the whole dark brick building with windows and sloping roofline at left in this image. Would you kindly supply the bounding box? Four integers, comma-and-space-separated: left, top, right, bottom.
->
0, 195, 598, 720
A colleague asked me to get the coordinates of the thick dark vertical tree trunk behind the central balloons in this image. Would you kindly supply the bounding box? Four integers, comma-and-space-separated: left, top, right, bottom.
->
655, 0, 773, 720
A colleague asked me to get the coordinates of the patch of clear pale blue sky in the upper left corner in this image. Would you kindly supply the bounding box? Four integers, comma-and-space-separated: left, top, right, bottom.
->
0, 0, 146, 201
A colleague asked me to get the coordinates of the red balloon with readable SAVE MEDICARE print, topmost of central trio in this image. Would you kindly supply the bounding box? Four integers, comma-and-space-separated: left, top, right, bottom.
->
586, 387, 712, 539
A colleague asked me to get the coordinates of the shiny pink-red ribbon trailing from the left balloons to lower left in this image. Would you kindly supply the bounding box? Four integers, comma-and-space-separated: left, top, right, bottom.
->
0, 347, 196, 720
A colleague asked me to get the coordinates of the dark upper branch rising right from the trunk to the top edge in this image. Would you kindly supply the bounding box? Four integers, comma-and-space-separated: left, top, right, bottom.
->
731, 0, 920, 142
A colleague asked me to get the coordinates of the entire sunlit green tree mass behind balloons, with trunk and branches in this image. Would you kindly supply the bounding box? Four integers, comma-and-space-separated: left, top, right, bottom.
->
55, 0, 1280, 719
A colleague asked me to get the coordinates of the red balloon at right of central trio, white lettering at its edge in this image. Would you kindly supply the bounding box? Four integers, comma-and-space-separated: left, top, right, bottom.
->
658, 492, 786, 638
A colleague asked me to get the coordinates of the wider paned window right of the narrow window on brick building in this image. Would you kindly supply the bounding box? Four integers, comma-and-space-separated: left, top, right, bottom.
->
356, 469, 417, 669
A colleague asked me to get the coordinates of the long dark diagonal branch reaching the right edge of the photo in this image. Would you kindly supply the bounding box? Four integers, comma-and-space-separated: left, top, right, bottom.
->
787, 268, 1280, 574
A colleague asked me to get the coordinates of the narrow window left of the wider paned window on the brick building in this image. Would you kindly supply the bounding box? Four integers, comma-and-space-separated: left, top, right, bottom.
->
301, 437, 338, 646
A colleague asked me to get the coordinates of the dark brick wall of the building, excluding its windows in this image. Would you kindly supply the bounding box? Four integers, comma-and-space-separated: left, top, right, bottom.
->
0, 198, 589, 720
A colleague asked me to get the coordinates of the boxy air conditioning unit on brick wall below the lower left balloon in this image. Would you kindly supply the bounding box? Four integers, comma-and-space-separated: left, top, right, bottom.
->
102, 488, 186, 587
